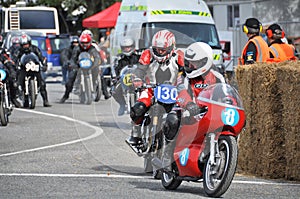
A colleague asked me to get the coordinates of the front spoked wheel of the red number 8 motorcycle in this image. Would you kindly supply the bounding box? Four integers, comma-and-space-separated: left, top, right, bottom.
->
203, 136, 238, 197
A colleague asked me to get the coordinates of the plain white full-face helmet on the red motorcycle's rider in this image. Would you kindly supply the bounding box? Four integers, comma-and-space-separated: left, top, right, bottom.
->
184, 42, 213, 78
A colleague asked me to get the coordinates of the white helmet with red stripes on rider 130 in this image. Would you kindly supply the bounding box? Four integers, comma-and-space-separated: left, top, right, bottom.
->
150, 30, 176, 63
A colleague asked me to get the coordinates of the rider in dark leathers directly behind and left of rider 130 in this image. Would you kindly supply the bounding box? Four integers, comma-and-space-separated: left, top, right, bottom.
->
111, 37, 141, 116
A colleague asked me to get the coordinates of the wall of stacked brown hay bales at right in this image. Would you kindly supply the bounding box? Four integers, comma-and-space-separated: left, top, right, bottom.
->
236, 62, 300, 180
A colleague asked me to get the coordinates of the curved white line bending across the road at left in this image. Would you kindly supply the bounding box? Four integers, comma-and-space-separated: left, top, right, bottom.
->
0, 109, 103, 157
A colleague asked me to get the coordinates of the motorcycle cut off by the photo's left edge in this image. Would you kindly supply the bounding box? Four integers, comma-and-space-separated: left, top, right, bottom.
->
0, 68, 12, 126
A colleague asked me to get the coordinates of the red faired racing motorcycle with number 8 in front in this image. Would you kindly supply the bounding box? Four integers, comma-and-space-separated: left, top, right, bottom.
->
161, 83, 245, 197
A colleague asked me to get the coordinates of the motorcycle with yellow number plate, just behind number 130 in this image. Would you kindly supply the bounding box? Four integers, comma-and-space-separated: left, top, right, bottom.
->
120, 65, 143, 114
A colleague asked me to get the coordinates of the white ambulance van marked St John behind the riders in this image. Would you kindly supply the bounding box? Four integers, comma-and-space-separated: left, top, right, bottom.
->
110, 0, 223, 65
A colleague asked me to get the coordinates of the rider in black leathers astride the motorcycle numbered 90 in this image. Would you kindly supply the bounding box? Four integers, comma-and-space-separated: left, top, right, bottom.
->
16, 34, 51, 107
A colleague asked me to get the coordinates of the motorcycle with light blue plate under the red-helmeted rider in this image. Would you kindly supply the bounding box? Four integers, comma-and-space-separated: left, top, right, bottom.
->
78, 52, 101, 104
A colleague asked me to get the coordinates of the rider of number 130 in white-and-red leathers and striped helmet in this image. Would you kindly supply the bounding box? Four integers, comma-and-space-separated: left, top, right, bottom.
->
126, 30, 184, 146
